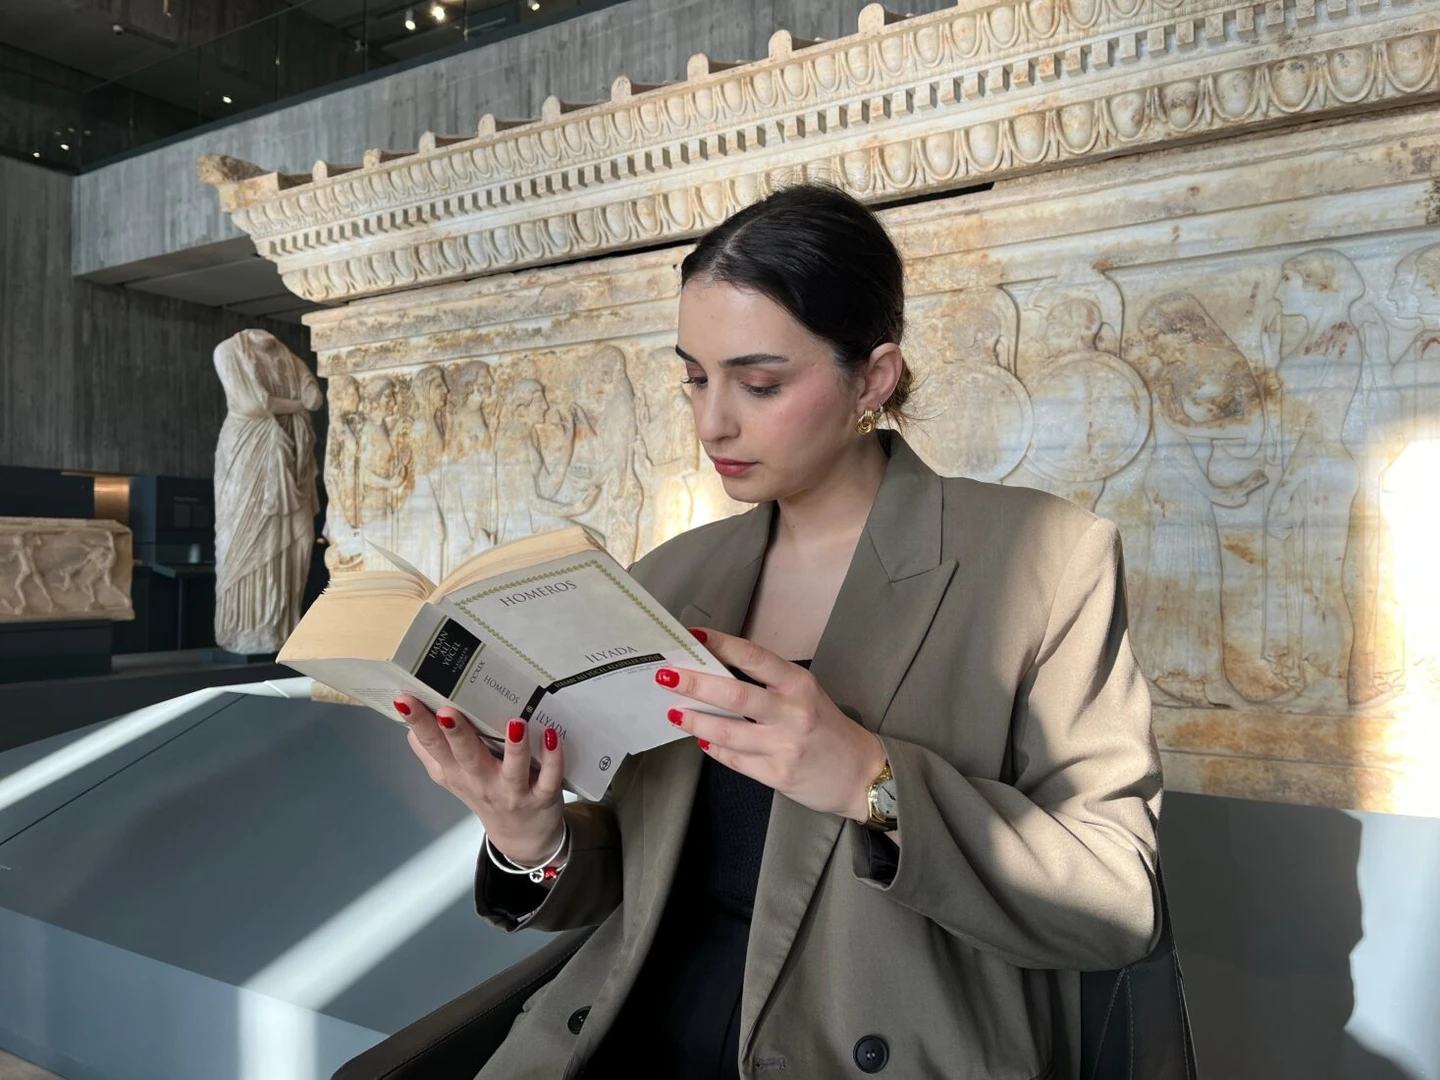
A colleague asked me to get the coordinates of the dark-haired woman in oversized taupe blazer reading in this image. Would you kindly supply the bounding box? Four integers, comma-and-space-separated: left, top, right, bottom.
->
396, 186, 1161, 1080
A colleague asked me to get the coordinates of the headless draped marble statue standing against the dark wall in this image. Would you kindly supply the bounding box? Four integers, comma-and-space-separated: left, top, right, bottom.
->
215, 330, 324, 652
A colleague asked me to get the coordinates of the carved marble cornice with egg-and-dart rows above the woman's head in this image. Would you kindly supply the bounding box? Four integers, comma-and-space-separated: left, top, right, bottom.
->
202, 0, 1440, 302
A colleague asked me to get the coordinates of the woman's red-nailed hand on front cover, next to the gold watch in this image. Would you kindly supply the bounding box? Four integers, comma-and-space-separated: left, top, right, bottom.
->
655, 629, 886, 821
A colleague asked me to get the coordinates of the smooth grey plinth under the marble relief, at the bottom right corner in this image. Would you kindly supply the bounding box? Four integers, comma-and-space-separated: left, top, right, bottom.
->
1161, 793, 1440, 1080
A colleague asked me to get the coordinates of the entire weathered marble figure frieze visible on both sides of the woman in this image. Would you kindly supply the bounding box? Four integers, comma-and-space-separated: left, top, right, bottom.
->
327, 236, 1440, 743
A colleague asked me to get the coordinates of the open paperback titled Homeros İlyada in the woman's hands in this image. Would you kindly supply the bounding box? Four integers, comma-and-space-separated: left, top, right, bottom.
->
279, 526, 733, 799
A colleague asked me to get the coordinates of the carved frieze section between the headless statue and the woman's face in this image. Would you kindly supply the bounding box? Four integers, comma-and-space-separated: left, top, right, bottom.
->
325, 344, 736, 577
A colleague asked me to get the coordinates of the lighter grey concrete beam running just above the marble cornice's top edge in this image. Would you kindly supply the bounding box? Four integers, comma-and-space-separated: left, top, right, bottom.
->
73, 0, 953, 275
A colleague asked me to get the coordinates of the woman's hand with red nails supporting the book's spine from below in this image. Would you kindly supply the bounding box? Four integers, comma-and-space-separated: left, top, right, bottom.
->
395, 694, 564, 867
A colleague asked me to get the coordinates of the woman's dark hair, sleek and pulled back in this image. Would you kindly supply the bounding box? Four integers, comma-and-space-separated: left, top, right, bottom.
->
680, 183, 913, 420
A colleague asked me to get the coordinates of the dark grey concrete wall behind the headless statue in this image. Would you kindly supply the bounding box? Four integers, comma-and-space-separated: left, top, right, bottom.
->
0, 158, 308, 477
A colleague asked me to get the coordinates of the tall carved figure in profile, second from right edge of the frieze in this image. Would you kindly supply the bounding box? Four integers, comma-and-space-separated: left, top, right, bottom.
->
1261, 249, 1365, 700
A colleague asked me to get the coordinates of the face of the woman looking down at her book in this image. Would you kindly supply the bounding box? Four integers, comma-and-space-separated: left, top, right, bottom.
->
675, 279, 864, 503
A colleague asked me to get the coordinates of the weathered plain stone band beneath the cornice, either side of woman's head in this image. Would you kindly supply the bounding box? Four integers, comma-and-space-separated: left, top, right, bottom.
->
305, 107, 1440, 377
